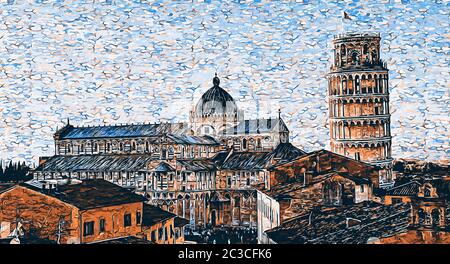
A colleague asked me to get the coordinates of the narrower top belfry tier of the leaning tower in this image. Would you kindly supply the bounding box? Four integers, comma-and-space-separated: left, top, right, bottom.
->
330, 33, 387, 72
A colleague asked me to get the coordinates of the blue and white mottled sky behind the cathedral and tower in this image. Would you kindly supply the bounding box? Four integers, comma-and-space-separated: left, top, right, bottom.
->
0, 0, 450, 165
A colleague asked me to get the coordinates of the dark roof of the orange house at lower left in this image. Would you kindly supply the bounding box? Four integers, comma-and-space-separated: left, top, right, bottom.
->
20, 179, 145, 210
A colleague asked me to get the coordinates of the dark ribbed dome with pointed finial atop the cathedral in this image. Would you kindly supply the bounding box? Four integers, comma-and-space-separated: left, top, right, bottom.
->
195, 75, 238, 116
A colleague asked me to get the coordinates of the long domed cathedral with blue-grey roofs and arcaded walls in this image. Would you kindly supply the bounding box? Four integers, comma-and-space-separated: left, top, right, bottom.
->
34, 75, 305, 230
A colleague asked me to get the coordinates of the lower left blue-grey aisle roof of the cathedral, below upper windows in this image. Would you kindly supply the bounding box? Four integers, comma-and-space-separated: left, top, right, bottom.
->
36, 154, 155, 172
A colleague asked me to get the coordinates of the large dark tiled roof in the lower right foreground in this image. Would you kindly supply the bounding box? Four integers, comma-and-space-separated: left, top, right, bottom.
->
266, 202, 411, 244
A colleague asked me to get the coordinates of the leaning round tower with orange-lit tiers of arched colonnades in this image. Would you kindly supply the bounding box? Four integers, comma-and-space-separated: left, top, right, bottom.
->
328, 33, 393, 187
